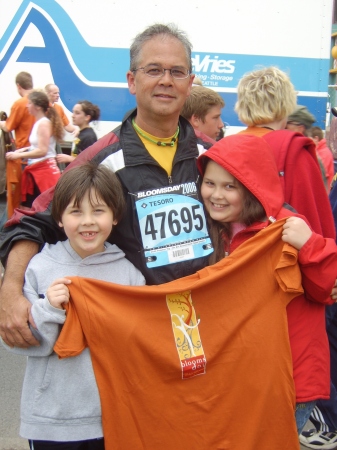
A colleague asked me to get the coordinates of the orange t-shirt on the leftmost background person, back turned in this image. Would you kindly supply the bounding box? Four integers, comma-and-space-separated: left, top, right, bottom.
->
6, 97, 35, 148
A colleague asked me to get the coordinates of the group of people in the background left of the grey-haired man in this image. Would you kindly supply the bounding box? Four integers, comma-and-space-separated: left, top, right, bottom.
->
0, 72, 100, 218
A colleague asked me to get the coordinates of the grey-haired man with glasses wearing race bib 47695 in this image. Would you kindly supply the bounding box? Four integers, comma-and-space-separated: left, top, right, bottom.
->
0, 24, 212, 347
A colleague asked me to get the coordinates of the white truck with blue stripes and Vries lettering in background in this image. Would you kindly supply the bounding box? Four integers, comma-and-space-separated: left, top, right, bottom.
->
0, 0, 337, 136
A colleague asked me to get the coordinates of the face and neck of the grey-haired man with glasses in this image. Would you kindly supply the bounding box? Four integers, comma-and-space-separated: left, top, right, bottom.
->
127, 36, 194, 128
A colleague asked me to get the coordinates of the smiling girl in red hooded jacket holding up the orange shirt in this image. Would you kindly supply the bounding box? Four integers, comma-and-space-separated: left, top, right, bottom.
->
198, 134, 337, 433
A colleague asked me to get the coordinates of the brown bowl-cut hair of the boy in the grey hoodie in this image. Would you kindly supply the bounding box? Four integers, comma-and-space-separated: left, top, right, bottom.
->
51, 162, 125, 222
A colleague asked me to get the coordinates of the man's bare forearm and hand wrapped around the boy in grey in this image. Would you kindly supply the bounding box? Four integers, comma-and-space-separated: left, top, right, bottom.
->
0, 241, 39, 348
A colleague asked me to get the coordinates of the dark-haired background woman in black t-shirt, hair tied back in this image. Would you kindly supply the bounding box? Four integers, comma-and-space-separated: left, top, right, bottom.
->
56, 100, 100, 163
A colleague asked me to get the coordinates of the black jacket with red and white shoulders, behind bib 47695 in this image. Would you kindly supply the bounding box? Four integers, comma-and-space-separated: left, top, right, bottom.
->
0, 110, 211, 284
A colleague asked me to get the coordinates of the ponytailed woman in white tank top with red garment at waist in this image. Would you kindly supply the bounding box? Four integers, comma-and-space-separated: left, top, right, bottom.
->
6, 91, 63, 208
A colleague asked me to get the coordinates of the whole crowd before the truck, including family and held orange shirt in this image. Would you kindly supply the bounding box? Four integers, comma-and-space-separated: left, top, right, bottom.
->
0, 24, 337, 450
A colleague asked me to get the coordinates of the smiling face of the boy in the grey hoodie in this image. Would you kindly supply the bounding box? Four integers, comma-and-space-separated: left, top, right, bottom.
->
59, 191, 117, 258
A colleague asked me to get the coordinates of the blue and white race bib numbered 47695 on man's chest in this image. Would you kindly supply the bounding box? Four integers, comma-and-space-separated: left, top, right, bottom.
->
136, 182, 213, 268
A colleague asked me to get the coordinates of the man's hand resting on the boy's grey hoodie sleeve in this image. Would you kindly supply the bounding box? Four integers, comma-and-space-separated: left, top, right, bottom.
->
0, 284, 39, 348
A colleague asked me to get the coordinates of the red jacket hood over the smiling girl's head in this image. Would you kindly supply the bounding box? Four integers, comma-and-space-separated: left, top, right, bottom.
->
197, 134, 284, 218
